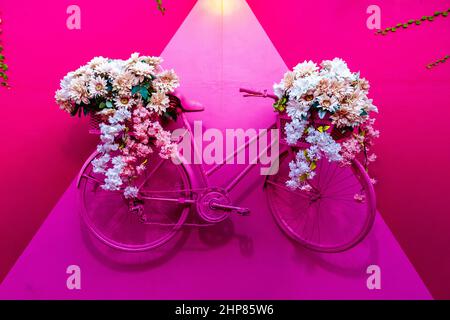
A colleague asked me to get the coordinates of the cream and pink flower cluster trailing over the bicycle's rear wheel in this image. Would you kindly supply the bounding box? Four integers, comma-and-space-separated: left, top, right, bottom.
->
55, 53, 179, 198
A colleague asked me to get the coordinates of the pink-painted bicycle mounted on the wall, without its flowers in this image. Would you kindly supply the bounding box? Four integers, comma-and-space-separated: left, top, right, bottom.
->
77, 89, 375, 252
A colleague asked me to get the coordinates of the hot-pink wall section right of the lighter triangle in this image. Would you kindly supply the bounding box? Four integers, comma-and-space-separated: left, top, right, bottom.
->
248, 0, 450, 299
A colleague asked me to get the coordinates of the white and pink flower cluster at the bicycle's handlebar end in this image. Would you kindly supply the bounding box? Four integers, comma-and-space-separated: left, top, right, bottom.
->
274, 58, 379, 190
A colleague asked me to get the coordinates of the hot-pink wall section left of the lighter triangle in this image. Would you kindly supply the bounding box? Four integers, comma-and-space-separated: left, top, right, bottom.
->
0, 0, 195, 279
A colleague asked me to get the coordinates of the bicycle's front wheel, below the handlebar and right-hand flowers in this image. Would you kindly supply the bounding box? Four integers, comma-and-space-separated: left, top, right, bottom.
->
265, 151, 376, 252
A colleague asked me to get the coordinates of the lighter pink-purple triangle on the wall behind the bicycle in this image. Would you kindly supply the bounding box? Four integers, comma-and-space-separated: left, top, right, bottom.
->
0, 0, 431, 299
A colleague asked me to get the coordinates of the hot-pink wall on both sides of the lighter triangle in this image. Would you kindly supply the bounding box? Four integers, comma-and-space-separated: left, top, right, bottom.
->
0, 0, 450, 298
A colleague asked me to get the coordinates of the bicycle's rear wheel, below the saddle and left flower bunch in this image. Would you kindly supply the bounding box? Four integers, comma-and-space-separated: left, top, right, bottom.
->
78, 153, 191, 251
